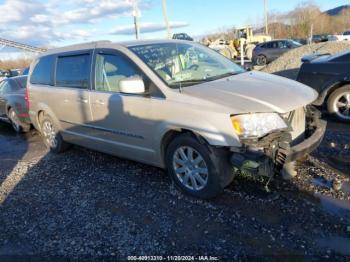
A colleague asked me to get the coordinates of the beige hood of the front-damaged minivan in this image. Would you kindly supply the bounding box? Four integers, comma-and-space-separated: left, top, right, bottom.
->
183, 72, 318, 114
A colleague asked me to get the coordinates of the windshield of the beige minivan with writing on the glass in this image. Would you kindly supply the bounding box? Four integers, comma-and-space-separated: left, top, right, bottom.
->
130, 42, 244, 88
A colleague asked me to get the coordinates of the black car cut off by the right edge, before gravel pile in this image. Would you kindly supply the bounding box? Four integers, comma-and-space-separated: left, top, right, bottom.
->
297, 50, 350, 123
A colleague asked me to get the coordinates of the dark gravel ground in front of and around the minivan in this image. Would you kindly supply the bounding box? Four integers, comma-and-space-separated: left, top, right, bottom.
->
0, 118, 350, 260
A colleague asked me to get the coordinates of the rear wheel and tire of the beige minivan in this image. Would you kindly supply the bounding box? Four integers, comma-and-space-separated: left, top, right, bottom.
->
40, 115, 70, 153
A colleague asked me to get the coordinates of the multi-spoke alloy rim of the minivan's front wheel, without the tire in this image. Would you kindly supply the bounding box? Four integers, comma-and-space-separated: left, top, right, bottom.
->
173, 146, 209, 191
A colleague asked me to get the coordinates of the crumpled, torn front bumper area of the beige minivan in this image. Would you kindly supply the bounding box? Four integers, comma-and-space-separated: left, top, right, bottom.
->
230, 107, 327, 176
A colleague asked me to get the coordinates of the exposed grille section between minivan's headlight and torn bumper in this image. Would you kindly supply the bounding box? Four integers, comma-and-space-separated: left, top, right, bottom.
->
283, 107, 306, 145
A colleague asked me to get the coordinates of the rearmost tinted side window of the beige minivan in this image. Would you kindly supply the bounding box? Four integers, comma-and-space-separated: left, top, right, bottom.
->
30, 56, 54, 85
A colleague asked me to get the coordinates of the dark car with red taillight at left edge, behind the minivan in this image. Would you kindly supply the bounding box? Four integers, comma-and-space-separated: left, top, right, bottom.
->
0, 76, 30, 132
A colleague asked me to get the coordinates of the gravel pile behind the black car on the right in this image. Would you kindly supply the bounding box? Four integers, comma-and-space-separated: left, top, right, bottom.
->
261, 41, 350, 79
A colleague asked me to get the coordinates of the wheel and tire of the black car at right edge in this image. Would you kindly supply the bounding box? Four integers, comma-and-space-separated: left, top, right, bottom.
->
327, 85, 350, 123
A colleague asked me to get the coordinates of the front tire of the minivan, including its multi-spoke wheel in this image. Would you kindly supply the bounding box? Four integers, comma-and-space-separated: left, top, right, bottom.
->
165, 134, 234, 199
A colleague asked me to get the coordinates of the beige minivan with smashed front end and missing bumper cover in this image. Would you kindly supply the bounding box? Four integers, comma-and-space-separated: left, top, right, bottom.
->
28, 40, 326, 198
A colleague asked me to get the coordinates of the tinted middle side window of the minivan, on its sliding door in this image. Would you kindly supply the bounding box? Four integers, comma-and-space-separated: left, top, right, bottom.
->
56, 54, 90, 89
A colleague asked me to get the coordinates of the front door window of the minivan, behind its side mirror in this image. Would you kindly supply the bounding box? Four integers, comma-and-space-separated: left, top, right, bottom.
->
95, 54, 142, 92
